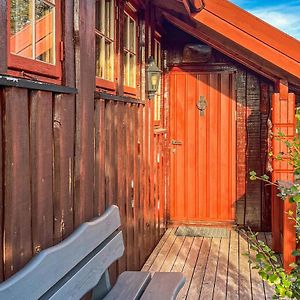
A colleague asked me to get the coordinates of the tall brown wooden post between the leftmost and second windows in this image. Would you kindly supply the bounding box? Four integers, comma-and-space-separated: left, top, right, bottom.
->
74, 0, 96, 226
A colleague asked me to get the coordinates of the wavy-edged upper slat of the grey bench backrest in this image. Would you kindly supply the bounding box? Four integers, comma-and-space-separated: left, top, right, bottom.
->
0, 206, 123, 300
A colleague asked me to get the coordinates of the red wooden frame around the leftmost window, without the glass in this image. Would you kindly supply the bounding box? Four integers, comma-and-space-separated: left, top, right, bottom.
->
7, 0, 63, 83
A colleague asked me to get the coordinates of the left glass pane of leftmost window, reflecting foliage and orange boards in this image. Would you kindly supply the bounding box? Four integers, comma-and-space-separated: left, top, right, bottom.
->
10, 0, 33, 58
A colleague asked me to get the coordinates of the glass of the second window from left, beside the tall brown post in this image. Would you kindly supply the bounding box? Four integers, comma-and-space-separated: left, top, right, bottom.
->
96, 0, 115, 82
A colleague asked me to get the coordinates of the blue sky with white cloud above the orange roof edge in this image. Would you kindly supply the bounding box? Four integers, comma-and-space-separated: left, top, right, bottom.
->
231, 0, 300, 40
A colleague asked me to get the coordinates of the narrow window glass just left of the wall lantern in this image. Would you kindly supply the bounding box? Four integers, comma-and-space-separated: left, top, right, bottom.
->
124, 12, 137, 88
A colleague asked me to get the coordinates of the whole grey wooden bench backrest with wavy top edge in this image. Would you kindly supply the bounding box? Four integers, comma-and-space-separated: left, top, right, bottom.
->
0, 206, 124, 300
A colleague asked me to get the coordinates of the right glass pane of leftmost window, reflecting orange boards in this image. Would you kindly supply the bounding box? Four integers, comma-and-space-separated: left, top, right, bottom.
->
35, 0, 55, 64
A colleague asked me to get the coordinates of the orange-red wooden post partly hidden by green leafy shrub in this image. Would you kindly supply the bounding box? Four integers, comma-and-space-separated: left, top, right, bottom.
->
272, 88, 296, 271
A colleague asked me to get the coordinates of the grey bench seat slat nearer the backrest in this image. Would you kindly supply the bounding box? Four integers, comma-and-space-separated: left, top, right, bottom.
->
103, 271, 151, 300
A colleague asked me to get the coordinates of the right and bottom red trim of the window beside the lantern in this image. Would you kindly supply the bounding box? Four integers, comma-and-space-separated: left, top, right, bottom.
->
123, 2, 140, 97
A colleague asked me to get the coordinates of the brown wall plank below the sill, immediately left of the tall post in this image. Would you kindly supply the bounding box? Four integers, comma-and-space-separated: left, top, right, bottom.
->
53, 94, 75, 244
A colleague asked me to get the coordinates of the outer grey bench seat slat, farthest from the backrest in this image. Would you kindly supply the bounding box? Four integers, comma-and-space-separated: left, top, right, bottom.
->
141, 272, 185, 300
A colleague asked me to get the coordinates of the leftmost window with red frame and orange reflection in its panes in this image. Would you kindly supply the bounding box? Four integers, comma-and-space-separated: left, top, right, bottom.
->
8, 0, 61, 77
